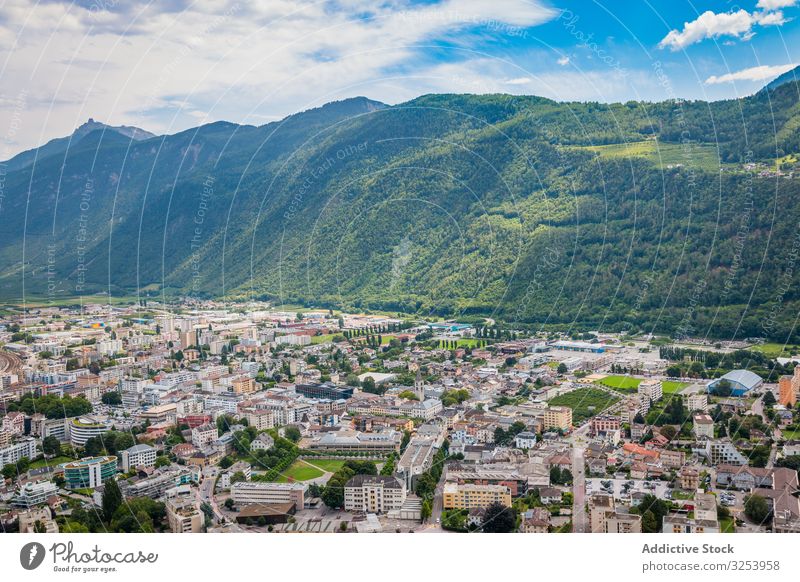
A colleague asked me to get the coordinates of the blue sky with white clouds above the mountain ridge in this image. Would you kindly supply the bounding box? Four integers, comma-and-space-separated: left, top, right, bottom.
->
0, 0, 800, 160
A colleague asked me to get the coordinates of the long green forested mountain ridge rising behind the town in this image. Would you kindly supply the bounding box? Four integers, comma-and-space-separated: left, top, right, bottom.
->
0, 82, 800, 341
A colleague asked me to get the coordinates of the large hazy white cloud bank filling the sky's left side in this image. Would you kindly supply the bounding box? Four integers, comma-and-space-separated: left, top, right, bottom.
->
0, 0, 558, 157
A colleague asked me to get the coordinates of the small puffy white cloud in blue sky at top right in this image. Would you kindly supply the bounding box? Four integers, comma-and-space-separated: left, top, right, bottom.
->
658, 6, 786, 50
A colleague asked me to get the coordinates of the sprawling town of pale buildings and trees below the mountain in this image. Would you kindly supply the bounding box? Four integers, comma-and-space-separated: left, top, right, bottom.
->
0, 301, 800, 533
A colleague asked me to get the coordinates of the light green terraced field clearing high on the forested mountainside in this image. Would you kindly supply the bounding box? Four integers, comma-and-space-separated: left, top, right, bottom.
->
576, 140, 727, 172
